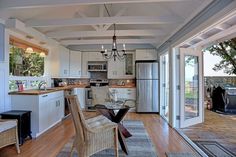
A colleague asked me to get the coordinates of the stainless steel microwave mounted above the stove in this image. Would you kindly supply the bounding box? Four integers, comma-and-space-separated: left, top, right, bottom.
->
88, 61, 107, 72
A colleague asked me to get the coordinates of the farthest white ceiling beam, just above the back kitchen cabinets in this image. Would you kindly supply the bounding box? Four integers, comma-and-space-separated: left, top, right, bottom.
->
60, 38, 159, 45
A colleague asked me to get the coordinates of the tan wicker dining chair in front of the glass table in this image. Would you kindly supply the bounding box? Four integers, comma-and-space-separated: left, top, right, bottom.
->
66, 95, 118, 157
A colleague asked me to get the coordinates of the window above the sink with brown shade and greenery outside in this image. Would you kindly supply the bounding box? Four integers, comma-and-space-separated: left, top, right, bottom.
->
9, 36, 48, 77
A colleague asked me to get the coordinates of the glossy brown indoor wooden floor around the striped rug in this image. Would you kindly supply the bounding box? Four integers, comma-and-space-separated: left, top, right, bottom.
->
0, 112, 197, 157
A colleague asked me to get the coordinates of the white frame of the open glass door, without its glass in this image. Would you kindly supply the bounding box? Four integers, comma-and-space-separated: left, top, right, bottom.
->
180, 48, 204, 128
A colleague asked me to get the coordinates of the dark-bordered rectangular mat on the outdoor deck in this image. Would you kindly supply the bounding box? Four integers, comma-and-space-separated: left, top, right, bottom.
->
193, 141, 236, 157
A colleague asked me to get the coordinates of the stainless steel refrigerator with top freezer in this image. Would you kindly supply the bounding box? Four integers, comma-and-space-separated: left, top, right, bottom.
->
136, 62, 159, 112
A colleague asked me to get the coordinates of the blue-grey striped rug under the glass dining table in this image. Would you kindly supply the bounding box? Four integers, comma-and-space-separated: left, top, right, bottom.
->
57, 120, 157, 157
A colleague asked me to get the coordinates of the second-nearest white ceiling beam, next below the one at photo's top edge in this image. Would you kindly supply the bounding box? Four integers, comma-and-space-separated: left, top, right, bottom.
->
25, 16, 182, 27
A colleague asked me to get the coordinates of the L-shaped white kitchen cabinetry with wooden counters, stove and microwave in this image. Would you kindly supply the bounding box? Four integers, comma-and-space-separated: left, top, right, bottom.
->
9, 43, 159, 137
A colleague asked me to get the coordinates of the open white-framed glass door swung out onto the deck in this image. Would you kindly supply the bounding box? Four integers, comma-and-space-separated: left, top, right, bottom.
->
180, 48, 203, 128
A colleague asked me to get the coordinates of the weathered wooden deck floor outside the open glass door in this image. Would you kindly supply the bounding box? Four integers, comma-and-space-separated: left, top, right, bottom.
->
181, 110, 236, 154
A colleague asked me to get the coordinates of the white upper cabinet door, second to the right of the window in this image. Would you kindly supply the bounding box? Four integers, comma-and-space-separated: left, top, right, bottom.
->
70, 51, 82, 78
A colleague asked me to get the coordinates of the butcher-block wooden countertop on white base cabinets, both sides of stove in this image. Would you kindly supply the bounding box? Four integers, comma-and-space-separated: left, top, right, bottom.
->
8, 84, 135, 95
